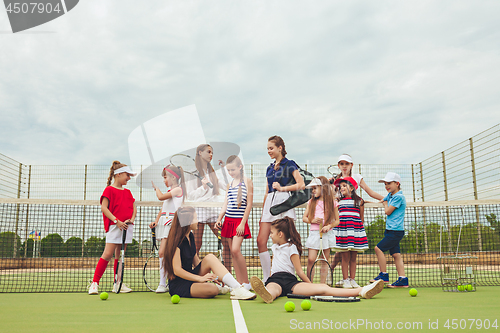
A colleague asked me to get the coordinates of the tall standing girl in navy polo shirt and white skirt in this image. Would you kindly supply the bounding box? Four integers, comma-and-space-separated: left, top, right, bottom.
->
257, 135, 305, 282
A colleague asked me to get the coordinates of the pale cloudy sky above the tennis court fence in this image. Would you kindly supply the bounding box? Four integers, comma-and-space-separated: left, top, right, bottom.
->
0, 0, 500, 165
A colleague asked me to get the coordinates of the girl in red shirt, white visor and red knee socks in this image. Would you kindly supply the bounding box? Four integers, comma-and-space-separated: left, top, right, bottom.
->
89, 161, 137, 295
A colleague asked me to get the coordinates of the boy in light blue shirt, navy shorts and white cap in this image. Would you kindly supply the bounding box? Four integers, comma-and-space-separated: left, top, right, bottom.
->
370, 172, 408, 288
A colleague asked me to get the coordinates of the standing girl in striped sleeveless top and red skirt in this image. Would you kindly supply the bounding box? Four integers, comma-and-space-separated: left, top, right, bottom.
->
215, 155, 253, 290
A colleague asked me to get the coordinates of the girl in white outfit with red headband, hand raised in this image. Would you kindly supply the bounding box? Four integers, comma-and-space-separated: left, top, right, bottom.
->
149, 165, 186, 293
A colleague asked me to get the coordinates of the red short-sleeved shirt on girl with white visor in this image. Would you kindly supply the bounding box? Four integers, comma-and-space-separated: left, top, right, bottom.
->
100, 186, 135, 232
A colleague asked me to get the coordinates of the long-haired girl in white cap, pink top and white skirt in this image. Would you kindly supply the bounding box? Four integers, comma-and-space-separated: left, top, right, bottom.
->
302, 176, 339, 283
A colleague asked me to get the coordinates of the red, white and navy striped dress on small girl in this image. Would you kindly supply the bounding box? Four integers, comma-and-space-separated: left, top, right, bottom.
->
334, 198, 368, 252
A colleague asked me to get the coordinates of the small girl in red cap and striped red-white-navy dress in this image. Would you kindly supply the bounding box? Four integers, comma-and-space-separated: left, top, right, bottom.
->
334, 177, 368, 288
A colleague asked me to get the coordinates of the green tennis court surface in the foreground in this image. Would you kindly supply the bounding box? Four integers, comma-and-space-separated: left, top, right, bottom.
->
0, 287, 500, 333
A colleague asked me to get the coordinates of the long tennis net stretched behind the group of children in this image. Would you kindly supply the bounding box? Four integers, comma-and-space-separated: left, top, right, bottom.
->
0, 199, 500, 293
